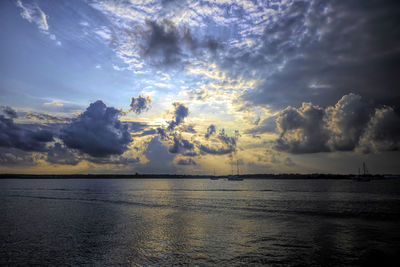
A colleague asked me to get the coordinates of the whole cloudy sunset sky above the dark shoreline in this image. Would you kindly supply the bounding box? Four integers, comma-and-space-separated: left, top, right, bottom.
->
0, 0, 400, 175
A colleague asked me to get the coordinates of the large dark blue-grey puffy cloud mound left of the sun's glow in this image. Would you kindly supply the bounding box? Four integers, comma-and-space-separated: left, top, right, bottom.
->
60, 100, 132, 157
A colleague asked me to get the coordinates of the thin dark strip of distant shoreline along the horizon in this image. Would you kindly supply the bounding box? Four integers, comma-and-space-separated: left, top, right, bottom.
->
0, 174, 400, 180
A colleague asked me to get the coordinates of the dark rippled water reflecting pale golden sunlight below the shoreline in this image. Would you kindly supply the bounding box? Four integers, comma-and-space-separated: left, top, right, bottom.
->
0, 179, 400, 266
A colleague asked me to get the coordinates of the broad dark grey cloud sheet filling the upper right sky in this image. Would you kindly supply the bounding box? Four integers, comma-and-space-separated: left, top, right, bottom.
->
225, 0, 400, 109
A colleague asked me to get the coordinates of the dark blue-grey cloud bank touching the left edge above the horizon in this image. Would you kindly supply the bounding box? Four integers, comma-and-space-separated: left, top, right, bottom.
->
0, 115, 53, 151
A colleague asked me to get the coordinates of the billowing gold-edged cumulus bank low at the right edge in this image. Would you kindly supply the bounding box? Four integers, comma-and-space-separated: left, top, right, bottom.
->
275, 94, 400, 154
